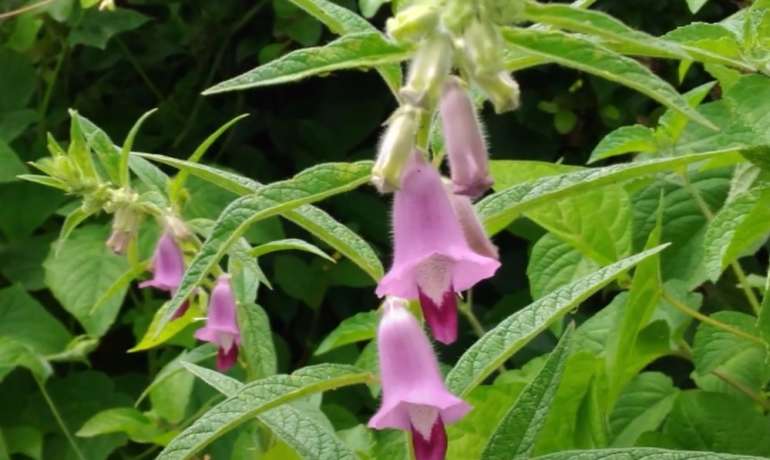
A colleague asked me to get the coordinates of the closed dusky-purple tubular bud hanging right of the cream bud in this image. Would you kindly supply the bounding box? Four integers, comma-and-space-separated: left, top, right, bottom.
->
440, 77, 493, 198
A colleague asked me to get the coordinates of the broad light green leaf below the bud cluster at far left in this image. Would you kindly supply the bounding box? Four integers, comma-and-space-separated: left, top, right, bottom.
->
44, 225, 128, 337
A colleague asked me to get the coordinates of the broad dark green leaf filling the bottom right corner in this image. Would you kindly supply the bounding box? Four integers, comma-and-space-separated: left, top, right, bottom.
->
663, 390, 770, 456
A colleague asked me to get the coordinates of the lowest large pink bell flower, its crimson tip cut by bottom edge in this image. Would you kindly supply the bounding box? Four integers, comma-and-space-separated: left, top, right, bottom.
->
369, 297, 471, 460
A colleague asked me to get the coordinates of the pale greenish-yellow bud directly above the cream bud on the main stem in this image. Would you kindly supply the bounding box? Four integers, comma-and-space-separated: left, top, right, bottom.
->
399, 33, 453, 108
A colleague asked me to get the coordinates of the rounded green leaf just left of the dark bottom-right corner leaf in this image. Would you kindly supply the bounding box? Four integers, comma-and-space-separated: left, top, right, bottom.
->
609, 372, 679, 447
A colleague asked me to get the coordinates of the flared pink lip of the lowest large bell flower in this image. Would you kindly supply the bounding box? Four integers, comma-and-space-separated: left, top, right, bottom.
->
368, 390, 473, 431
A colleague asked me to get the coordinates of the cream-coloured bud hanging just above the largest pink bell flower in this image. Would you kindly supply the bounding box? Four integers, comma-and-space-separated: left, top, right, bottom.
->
372, 105, 420, 193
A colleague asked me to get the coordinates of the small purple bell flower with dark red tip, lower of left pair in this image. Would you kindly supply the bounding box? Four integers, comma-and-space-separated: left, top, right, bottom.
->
195, 275, 241, 371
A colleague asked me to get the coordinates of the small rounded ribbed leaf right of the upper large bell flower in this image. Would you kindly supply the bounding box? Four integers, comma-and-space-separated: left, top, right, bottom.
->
527, 233, 599, 299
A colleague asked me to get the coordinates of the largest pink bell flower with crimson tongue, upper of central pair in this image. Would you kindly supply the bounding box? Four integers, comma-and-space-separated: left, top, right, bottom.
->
377, 151, 500, 343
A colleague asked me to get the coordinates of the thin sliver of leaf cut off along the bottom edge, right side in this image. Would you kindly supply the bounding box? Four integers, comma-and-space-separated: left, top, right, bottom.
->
535, 447, 761, 460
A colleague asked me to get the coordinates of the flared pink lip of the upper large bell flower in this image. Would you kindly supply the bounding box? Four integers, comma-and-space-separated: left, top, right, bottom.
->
375, 248, 500, 299
